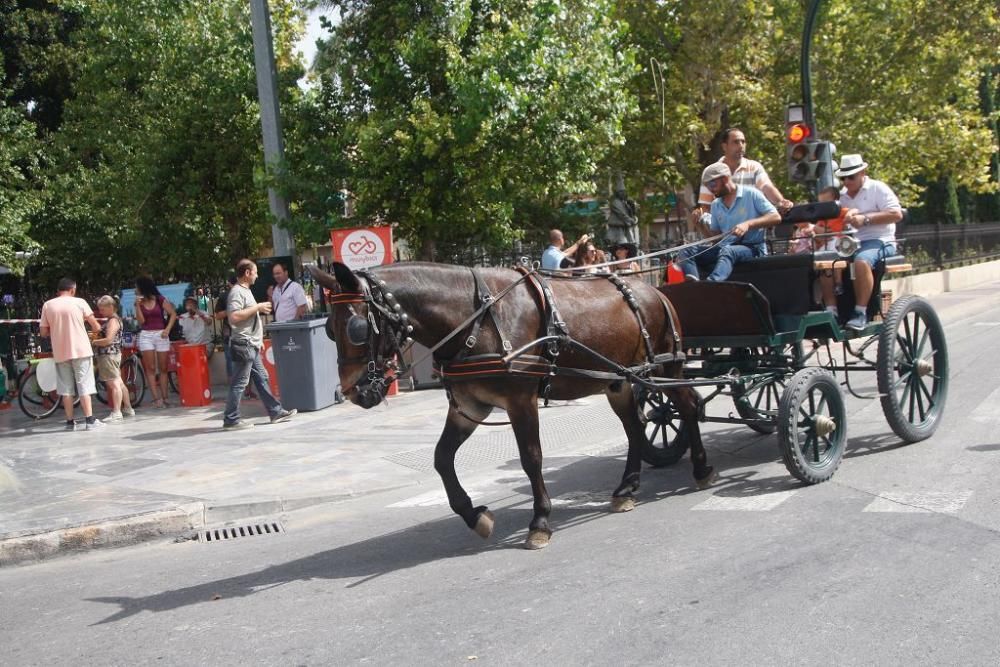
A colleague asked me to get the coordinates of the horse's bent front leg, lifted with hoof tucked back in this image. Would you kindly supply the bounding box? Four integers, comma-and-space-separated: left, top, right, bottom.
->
434, 404, 493, 539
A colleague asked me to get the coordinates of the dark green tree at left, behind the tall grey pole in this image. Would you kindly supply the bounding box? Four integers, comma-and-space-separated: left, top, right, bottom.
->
32, 0, 301, 282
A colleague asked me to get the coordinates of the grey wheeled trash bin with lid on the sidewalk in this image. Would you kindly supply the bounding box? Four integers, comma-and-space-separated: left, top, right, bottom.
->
267, 318, 340, 410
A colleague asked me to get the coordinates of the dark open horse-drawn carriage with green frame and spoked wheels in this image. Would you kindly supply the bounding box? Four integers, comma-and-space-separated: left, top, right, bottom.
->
636, 207, 948, 484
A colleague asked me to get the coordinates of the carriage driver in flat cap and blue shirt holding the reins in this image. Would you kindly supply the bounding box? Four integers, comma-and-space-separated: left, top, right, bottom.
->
678, 162, 781, 281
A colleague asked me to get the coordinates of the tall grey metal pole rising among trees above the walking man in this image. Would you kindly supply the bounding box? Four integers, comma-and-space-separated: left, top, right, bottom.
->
250, 0, 295, 256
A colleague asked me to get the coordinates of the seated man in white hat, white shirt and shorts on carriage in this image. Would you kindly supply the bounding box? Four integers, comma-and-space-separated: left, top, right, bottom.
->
824, 153, 903, 331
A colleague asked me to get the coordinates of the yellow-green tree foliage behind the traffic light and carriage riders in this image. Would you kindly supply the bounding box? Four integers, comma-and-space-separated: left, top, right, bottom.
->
617, 0, 1000, 213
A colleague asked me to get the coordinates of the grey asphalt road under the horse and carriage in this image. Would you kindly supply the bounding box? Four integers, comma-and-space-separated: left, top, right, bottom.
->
0, 293, 1000, 665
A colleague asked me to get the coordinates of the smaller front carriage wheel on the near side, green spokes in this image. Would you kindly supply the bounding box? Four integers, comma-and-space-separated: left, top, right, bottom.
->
778, 368, 847, 484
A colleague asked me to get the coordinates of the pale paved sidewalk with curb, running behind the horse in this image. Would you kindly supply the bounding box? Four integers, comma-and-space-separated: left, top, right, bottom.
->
0, 283, 1000, 566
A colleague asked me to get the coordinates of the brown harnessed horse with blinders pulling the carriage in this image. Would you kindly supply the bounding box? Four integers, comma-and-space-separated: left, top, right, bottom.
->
312, 262, 714, 549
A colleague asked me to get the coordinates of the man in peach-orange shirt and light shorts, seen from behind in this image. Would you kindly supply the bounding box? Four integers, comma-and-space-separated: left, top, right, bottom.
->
39, 278, 104, 431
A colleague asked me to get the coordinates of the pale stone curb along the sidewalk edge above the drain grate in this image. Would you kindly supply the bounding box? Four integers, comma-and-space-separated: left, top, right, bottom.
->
0, 483, 415, 567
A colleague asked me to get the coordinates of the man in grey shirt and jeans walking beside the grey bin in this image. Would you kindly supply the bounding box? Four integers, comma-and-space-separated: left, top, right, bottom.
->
222, 259, 297, 429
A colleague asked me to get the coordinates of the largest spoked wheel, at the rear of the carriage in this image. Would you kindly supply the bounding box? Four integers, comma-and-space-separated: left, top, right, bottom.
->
876, 296, 948, 442
